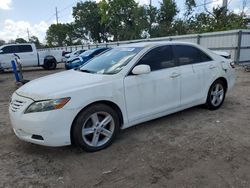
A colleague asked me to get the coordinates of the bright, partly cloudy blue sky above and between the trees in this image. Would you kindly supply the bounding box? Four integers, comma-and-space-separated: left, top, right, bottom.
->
0, 0, 250, 43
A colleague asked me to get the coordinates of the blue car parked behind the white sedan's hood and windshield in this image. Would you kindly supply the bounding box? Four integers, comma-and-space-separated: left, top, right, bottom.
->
65, 48, 110, 69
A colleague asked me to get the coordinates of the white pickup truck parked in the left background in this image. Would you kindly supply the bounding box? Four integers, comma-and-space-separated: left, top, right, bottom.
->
0, 43, 63, 71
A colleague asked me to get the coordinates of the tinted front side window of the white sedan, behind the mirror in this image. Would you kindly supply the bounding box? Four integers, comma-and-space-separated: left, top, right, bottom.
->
137, 46, 176, 71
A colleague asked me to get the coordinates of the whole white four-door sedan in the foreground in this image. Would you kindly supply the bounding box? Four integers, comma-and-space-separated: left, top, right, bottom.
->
9, 42, 235, 151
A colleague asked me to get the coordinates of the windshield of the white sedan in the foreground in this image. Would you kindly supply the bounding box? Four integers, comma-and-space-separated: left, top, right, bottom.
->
80, 47, 142, 74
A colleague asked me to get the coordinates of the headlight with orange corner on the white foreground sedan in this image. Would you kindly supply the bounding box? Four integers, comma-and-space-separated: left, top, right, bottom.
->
24, 97, 70, 114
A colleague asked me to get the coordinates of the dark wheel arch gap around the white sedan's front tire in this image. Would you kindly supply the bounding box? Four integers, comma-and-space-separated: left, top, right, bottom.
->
70, 100, 124, 144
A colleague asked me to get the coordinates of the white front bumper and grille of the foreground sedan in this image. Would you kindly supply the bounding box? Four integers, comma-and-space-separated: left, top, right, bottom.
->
9, 93, 77, 146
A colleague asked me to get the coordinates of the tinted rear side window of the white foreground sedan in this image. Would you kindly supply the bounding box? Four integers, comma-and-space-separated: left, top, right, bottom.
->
173, 45, 212, 65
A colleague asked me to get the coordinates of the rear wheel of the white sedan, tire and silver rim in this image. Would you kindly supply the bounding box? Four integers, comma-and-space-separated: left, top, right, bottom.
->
206, 80, 226, 110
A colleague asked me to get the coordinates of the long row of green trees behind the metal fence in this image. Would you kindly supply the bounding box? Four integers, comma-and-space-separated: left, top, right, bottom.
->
46, 0, 247, 46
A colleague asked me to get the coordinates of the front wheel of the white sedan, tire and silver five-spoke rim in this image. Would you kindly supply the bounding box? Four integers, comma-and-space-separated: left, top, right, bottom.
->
72, 104, 120, 152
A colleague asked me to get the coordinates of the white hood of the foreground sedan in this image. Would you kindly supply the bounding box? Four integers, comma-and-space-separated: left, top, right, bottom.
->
16, 70, 109, 100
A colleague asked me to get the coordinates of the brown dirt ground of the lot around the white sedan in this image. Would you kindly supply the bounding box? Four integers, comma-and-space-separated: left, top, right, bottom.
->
0, 65, 250, 188
